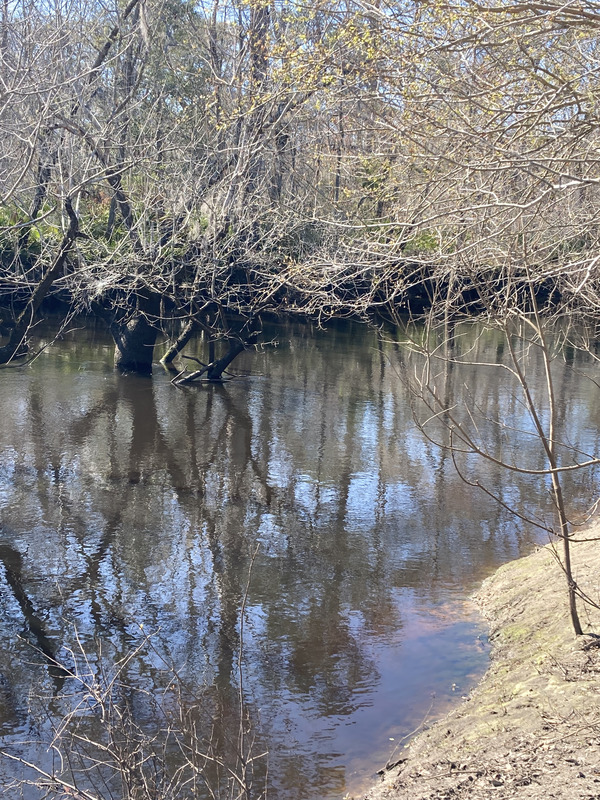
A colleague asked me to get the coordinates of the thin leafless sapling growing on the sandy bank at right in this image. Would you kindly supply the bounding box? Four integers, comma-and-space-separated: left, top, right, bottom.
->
407, 281, 600, 635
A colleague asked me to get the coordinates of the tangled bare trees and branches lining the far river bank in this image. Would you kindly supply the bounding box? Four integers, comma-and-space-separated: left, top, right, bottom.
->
0, 0, 600, 369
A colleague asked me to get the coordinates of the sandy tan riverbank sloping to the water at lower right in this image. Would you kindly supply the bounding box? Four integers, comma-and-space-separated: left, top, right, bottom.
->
365, 524, 600, 800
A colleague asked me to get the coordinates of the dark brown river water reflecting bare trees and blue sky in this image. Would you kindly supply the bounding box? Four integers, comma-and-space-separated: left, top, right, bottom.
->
0, 316, 600, 800
